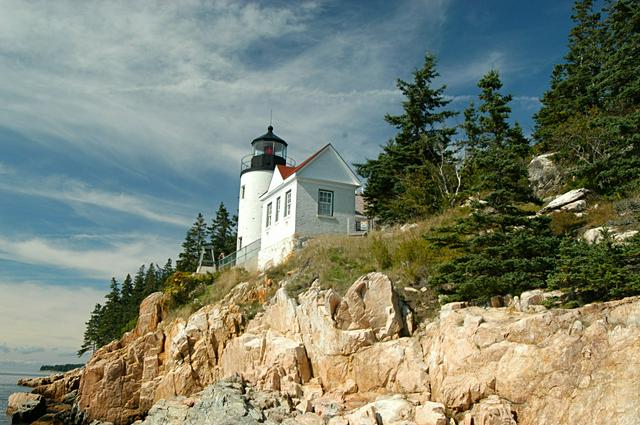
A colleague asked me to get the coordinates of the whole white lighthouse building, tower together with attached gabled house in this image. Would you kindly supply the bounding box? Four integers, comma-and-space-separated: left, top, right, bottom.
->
234, 126, 366, 270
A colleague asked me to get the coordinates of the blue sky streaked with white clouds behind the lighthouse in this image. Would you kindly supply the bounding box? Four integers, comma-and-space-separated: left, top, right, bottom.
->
0, 0, 572, 363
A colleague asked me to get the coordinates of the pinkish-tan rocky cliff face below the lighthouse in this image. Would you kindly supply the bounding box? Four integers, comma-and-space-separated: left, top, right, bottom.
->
58, 273, 640, 425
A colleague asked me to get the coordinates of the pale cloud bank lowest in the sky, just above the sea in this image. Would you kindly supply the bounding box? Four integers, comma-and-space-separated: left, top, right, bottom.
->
0, 281, 104, 362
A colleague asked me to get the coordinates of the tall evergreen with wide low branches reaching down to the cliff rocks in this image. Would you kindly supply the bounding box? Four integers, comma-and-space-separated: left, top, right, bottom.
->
431, 71, 558, 302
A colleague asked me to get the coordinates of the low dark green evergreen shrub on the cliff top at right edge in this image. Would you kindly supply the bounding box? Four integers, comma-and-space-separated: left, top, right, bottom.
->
549, 235, 640, 304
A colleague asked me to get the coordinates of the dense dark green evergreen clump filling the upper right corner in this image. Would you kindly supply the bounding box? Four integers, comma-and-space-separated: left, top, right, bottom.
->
535, 0, 640, 196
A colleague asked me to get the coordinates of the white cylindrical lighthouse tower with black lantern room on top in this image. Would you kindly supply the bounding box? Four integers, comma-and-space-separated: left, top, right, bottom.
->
236, 125, 287, 250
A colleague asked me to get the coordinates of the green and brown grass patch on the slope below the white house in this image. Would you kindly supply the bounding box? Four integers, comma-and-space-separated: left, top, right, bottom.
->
266, 208, 469, 320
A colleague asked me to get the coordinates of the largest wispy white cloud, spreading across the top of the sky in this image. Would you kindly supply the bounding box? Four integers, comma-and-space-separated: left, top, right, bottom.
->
0, 0, 449, 178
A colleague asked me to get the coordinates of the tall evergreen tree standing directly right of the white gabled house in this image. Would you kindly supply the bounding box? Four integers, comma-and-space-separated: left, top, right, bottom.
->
356, 55, 456, 222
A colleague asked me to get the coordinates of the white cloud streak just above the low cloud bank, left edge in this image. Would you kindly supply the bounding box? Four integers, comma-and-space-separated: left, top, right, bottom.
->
0, 235, 176, 279
